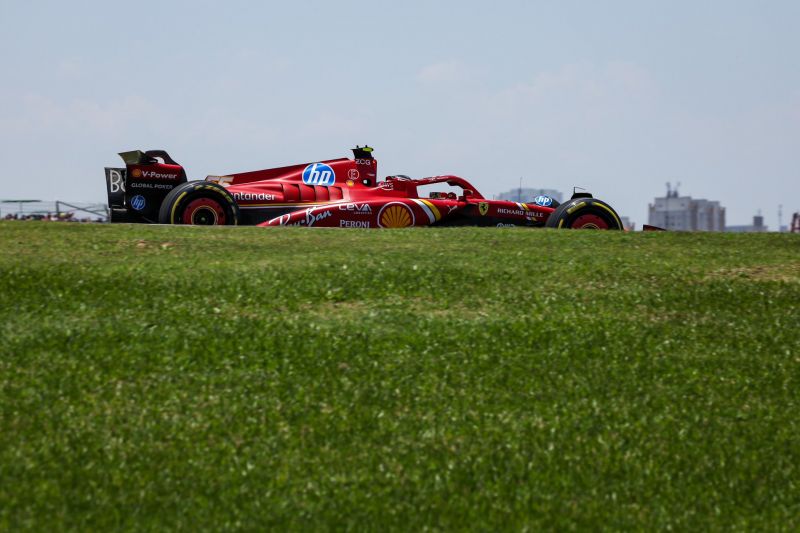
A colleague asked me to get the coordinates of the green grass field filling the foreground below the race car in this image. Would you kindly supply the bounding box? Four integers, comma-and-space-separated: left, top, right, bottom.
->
0, 222, 800, 531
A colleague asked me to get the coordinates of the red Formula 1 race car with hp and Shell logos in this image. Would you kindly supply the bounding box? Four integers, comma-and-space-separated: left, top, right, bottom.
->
106, 146, 622, 229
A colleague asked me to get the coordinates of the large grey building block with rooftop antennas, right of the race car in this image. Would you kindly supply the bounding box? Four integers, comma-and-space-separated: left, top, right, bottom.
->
648, 188, 725, 231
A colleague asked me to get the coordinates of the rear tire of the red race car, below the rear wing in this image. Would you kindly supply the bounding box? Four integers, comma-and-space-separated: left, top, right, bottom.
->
158, 181, 239, 226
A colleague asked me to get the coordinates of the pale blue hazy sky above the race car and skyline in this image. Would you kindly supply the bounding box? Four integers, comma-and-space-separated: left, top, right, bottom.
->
0, 0, 800, 224
